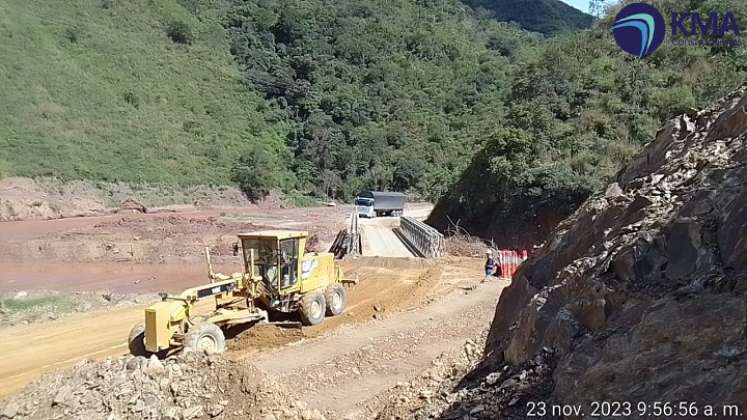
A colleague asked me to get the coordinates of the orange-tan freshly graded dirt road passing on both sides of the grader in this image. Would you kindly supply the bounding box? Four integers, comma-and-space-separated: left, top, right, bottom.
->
0, 258, 486, 396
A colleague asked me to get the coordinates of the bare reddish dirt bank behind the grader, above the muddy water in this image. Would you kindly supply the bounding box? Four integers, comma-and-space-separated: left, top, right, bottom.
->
0, 206, 350, 266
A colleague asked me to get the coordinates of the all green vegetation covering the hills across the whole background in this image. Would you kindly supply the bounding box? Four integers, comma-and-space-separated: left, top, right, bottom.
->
0, 0, 747, 226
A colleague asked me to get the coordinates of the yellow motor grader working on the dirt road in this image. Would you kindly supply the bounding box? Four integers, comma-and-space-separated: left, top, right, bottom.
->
128, 230, 347, 356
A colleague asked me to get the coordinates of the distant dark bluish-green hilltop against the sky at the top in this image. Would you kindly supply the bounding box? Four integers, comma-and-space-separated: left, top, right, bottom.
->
464, 0, 594, 35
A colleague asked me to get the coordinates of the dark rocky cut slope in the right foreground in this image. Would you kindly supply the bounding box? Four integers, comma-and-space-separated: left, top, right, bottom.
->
380, 89, 747, 419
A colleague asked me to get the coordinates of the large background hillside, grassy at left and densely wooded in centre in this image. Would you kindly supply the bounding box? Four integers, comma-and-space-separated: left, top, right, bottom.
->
0, 0, 533, 198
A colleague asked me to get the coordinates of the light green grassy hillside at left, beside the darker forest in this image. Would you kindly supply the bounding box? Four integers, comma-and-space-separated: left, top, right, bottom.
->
0, 0, 284, 185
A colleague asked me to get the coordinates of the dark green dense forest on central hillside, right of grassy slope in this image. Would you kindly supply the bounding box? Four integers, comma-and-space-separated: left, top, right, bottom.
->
225, 0, 531, 197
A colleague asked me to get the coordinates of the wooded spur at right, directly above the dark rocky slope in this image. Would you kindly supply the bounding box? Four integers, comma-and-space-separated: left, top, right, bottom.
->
430, 0, 747, 247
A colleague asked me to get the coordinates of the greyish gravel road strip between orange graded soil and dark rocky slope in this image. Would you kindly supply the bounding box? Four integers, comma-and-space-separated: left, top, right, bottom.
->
253, 267, 507, 419
